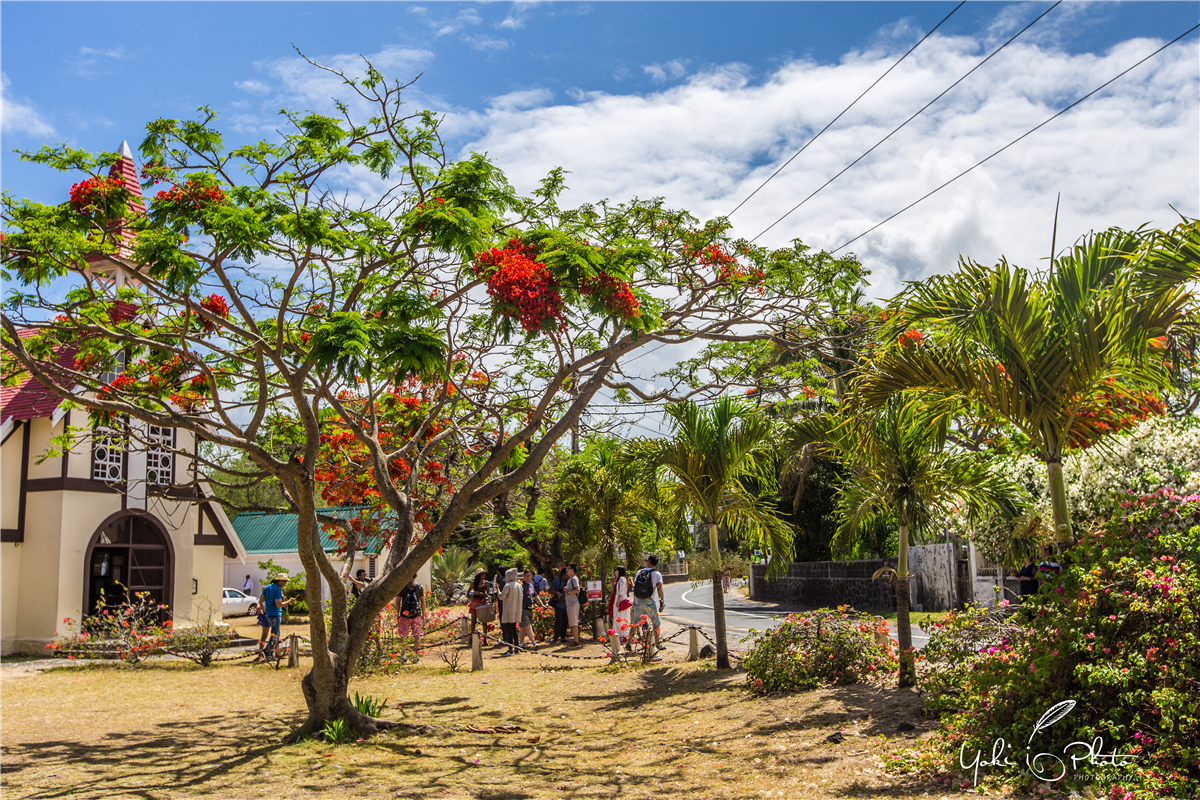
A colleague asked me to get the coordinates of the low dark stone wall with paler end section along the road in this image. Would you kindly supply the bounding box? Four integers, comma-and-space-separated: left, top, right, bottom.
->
750, 545, 955, 610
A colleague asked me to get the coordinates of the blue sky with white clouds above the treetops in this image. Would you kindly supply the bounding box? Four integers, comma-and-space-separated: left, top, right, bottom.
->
0, 0, 1200, 431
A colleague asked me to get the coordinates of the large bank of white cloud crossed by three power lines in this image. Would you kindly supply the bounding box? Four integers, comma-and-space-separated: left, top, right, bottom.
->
446, 28, 1200, 303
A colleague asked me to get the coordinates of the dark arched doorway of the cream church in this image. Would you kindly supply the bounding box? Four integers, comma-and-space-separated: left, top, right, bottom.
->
84, 511, 175, 619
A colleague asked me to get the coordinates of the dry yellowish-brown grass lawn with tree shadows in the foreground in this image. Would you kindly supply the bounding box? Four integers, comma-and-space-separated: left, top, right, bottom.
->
0, 645, 998, 800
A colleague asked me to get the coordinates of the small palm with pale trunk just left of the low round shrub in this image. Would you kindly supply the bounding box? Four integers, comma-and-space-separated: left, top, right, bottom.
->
618, 397, 794, 669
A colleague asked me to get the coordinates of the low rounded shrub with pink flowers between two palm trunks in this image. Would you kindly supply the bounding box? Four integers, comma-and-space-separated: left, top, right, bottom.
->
742, 606, 898, 694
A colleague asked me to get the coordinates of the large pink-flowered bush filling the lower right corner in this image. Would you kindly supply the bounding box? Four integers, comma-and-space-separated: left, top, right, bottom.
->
925, 489, 1200, 799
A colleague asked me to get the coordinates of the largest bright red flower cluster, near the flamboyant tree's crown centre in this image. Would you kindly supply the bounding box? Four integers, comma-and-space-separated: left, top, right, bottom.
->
472, 239, 566, 333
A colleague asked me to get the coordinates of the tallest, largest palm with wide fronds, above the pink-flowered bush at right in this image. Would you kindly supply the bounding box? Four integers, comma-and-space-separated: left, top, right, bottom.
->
858, 227, 1200, 541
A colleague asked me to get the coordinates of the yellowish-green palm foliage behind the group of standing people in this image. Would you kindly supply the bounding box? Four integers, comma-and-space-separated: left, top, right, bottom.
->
554, 438, 652, 573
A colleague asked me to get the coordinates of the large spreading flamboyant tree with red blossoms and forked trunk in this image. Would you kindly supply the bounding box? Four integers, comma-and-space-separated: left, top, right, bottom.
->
2, 59, 860, 735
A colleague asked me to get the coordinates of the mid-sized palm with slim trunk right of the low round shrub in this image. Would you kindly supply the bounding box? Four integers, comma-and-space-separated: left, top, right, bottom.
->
784, 396, 1016, 686
